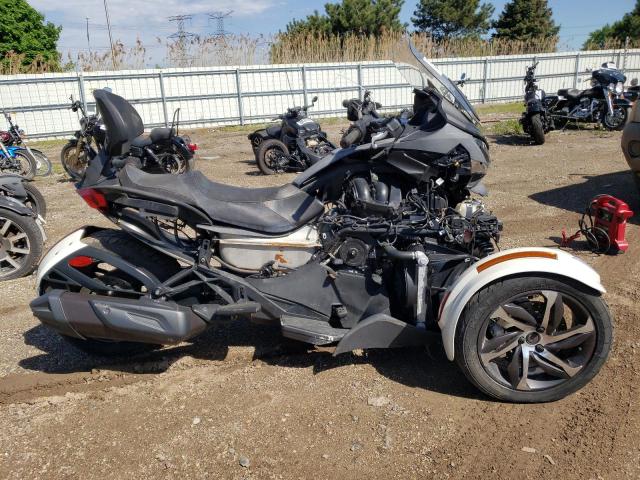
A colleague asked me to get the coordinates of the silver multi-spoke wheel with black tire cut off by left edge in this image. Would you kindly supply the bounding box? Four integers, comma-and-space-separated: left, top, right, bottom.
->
0, 210, 43, 280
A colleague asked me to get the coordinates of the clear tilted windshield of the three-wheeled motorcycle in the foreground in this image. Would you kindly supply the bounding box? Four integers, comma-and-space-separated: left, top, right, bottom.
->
395, 38, 480, 125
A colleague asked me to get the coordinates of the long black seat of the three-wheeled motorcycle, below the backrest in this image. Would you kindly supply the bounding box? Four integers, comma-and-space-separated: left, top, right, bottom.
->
119, 165, 324, 235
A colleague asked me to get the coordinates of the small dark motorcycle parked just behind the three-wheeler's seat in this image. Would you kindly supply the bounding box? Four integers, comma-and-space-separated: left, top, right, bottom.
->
248, 97, 336, 175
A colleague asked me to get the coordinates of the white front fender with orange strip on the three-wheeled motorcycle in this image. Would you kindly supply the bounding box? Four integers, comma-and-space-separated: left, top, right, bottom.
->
438, 248, 605, 360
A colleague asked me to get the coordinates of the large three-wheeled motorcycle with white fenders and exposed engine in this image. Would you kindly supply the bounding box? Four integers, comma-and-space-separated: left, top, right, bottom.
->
31, 41, 612, 402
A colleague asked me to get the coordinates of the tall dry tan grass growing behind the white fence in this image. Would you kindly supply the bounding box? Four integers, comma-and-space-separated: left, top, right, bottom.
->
0, 32, 640, 75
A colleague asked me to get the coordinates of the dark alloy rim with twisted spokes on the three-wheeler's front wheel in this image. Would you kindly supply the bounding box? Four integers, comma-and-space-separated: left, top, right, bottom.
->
478, 290, 597, 391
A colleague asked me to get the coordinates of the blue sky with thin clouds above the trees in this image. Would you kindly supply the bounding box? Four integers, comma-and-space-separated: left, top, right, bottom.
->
28, 0, 635, 65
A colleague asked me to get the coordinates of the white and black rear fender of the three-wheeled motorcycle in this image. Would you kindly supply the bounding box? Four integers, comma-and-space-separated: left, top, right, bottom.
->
36, 227, 166, 295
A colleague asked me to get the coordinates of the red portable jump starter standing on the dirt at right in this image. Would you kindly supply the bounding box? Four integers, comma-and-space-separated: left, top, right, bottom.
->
591, 195, 633, 252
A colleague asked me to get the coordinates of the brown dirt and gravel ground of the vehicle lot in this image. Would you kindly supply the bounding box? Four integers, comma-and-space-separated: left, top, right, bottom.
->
0, 121, 640, 479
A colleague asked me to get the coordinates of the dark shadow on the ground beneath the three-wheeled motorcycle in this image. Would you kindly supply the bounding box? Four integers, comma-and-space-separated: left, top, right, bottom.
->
20, 320, 483, 398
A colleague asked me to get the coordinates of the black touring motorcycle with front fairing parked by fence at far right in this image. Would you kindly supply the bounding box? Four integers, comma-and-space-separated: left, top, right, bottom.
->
540, 62, 631, 130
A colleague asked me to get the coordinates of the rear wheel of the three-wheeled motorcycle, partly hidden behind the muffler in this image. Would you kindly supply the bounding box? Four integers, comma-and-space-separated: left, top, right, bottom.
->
44, 229, 180, 357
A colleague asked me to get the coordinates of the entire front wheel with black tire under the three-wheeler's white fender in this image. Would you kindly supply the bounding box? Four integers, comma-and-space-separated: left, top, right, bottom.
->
455, 277, 613, 403
